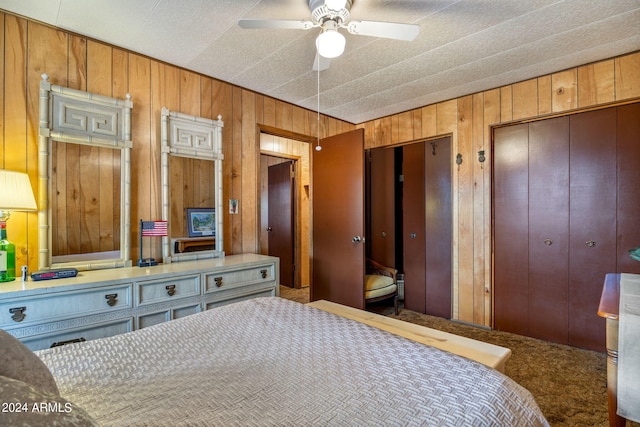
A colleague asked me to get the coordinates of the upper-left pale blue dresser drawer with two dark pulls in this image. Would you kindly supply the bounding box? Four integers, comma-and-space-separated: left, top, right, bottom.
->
0, 283, 133, 328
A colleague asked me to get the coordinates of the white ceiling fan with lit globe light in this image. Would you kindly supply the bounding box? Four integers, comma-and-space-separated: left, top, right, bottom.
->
238, 0, 420, 70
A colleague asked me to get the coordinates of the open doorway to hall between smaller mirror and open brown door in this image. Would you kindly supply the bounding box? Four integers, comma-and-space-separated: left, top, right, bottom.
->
259, 132, 311, 289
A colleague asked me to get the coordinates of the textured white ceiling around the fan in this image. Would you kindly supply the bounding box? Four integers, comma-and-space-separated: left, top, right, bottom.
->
0, 0, 640, 124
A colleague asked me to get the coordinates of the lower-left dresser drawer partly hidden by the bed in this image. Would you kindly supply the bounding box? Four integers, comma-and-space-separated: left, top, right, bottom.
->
21, 317, 133, 350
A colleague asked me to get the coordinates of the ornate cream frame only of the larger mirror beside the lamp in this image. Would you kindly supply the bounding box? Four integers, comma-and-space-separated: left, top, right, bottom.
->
38, 74, 133, 270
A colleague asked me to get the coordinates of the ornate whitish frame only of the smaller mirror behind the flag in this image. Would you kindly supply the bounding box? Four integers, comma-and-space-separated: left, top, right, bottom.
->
161, 108, 224, 263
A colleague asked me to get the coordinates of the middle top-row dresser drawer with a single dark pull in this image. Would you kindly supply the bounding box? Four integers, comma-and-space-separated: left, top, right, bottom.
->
136, 274, 200, 305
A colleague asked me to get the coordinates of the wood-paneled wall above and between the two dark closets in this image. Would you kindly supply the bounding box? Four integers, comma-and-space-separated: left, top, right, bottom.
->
357, 52, 640, 326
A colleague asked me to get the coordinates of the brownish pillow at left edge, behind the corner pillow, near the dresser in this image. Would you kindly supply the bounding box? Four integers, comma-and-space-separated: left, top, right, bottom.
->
0, 329, 59, 394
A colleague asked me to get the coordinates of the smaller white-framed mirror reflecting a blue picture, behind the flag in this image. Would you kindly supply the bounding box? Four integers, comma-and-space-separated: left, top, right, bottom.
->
161, 108, 224, 263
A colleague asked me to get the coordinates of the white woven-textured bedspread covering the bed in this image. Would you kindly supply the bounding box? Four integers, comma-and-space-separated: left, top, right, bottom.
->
37, 297, 548, 427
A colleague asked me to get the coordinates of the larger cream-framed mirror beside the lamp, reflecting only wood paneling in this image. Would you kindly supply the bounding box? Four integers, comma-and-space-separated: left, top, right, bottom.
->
38, 74, 133, 270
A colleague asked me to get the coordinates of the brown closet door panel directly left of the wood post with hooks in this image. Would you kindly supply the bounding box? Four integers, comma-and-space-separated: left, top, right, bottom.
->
424, 137, 453, 319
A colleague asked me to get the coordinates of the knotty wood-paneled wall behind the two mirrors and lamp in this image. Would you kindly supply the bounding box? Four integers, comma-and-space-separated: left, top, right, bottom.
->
0, 11, 355, 271
